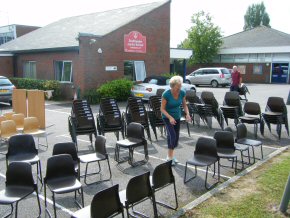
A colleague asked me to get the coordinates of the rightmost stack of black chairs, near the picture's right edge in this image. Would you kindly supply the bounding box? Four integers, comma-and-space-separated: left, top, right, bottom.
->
262, 97, 289, 140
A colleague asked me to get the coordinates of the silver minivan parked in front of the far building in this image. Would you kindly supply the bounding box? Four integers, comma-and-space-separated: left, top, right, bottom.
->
185, 67, 232, 87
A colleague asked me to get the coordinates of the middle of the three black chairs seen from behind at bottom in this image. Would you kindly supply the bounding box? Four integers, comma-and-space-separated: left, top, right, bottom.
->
119, 172, 157, 217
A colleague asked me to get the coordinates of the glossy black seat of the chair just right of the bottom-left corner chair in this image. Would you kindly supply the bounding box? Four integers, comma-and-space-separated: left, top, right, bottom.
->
47, 176, 82, 194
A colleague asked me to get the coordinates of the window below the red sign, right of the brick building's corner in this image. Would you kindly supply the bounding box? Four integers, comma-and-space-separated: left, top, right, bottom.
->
124, 61, 146, 81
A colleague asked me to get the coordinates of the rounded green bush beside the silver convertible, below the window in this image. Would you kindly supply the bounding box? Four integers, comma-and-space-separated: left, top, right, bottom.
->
97, 79, 133, 101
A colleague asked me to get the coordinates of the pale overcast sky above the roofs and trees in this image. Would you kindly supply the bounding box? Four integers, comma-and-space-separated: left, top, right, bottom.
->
0, 0, 290, 48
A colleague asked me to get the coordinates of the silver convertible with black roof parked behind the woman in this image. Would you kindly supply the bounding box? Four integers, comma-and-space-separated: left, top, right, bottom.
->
131, 76, 196, 100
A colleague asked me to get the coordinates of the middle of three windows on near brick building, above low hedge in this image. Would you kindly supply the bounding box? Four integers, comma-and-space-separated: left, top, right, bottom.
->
54, 61, 72, 82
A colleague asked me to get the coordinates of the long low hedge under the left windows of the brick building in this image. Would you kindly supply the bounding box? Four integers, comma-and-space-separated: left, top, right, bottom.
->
9, 77, 61, 100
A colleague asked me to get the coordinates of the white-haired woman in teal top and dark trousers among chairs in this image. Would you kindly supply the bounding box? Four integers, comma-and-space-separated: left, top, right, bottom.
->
161, 76, 191, 165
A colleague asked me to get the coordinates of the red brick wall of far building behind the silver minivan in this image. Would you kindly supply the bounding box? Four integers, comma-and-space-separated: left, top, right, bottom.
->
187, 63, 271, 83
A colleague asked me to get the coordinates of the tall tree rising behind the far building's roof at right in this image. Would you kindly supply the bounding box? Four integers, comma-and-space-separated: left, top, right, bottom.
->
244, 2, 271, 30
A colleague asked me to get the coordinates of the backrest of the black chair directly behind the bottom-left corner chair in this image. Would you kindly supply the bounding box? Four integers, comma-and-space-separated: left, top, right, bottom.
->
6, 134, 38, 157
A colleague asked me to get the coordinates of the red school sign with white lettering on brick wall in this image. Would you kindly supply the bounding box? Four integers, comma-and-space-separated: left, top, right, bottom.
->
124, 31, 146, 53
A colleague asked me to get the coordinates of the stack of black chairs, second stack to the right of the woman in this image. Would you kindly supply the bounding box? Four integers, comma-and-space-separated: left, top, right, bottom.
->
196, 91, 224, 129
